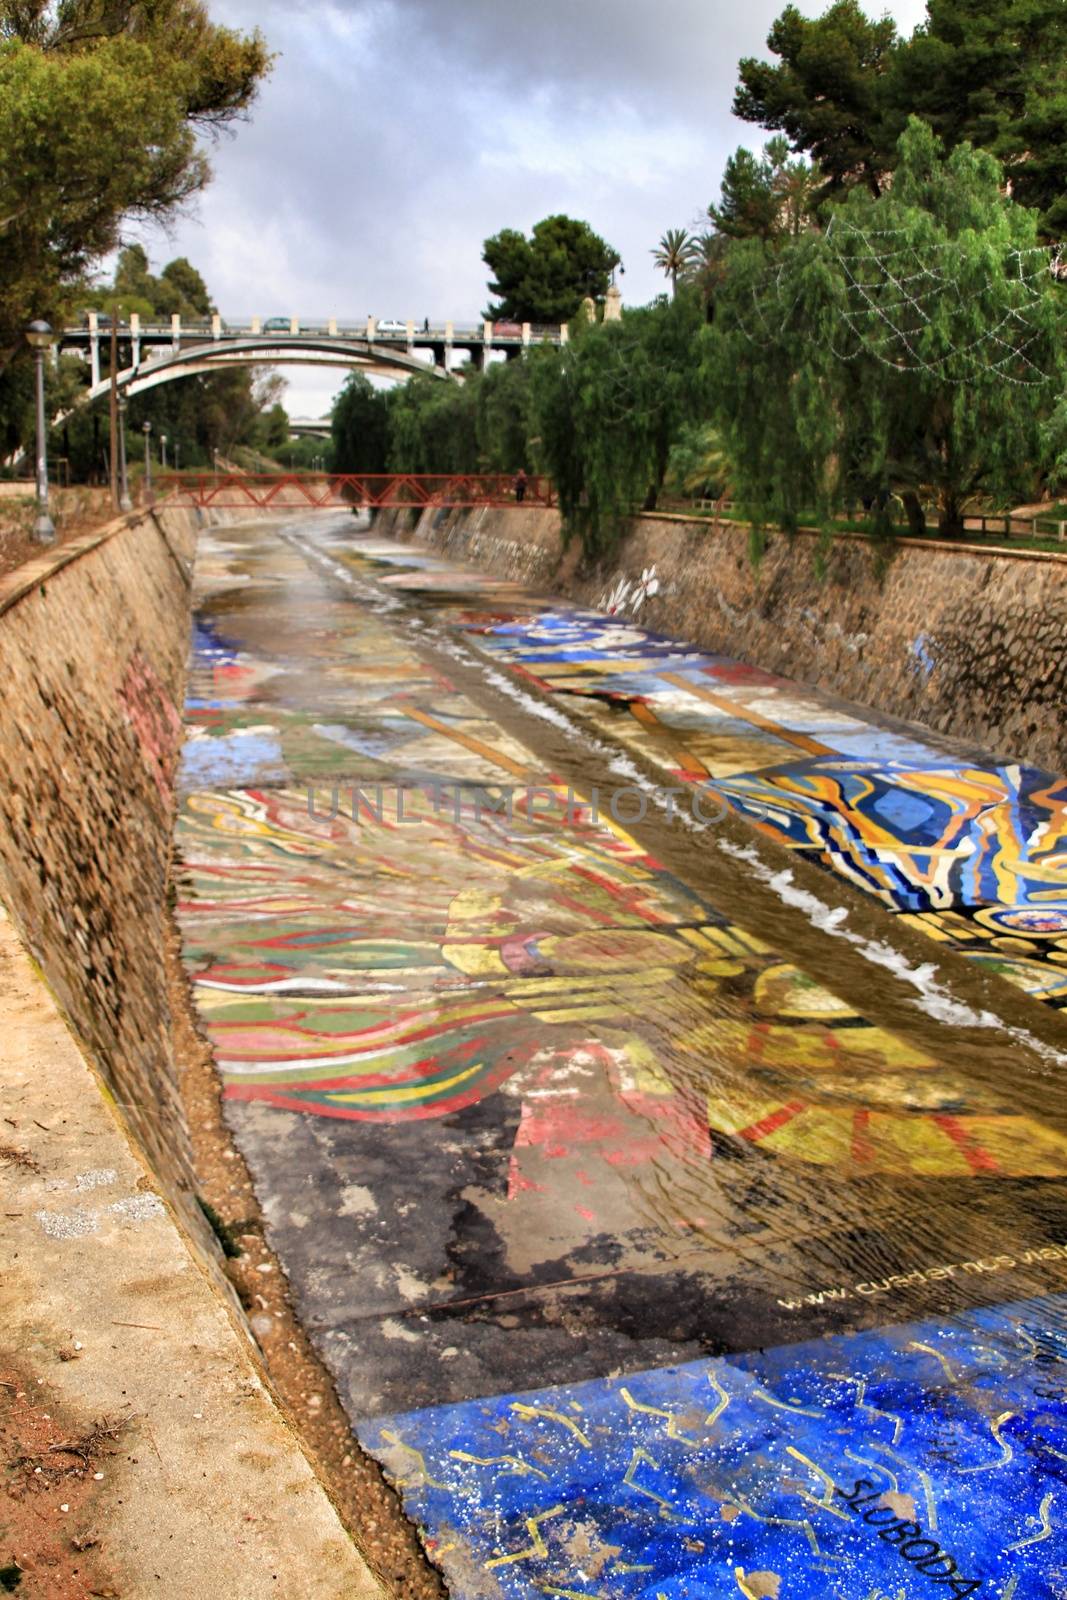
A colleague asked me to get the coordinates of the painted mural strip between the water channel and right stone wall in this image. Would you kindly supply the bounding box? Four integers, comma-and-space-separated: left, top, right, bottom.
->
447, 610, 1067, 1005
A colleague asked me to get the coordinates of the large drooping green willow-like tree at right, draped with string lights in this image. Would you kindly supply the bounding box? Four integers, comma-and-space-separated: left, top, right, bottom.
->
709, 118, 1064, 534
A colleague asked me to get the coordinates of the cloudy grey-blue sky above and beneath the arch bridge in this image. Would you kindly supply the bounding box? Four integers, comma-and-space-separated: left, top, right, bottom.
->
142, 0, 925, 416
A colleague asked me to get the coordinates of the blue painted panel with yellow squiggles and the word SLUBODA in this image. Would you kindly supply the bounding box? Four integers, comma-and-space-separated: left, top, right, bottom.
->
360, 1296, 1067, 1600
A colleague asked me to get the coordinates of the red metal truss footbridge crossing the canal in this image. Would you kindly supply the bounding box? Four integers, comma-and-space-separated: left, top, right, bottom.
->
157, 472, 553, 510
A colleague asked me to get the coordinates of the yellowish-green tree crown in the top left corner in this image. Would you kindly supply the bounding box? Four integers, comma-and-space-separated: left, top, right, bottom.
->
0, 0, 269, 368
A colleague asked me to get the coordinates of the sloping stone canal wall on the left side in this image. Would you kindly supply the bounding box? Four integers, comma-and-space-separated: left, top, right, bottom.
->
0, 512, 195, 1194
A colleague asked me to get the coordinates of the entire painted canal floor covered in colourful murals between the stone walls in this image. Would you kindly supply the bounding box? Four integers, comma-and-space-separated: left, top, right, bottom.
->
176, 517, 1067, 1600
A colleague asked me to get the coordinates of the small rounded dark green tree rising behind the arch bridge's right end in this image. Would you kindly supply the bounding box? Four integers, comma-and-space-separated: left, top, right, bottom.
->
482, 216, 619, 325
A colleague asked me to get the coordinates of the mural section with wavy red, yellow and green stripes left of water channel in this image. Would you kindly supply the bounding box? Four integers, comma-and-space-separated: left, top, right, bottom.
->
178, 789, 1067, 1176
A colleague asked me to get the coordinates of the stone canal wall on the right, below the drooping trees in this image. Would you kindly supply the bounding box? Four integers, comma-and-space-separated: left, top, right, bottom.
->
379, 509, 1067, 771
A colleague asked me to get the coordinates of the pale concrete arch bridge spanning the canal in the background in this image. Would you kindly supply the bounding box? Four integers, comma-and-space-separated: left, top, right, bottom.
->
58, 312, 566, 402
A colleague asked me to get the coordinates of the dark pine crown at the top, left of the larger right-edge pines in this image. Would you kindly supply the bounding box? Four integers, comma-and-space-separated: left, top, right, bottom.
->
734, 0, 899, 198
